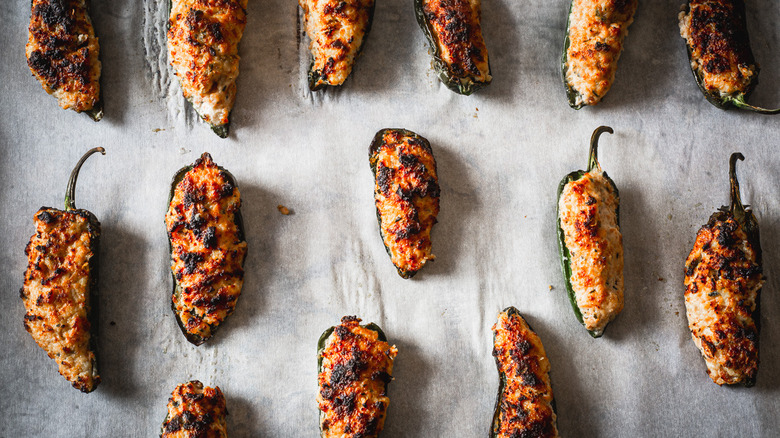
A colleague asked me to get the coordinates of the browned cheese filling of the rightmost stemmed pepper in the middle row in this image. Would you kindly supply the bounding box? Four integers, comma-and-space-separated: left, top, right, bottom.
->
685, 213, 764, 385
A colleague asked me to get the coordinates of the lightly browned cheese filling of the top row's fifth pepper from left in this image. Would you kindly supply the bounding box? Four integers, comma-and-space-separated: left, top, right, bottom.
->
565, 0, 637, 105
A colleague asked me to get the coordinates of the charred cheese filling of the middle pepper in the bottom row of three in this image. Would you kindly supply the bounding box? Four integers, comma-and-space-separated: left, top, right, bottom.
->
317, 316, 398, 438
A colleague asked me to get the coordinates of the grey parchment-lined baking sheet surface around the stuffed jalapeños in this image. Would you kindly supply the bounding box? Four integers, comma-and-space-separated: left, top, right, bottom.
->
0, 0, 780, 437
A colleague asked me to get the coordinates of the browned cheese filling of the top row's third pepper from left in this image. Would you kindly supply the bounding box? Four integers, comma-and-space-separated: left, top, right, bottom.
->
298, 0, 374, 90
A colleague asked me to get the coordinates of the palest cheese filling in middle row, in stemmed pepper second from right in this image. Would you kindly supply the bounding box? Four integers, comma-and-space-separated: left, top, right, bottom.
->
558, 168, 623, 334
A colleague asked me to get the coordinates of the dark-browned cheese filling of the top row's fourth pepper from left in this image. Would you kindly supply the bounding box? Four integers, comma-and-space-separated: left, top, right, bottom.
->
422, 0, 492, 83
